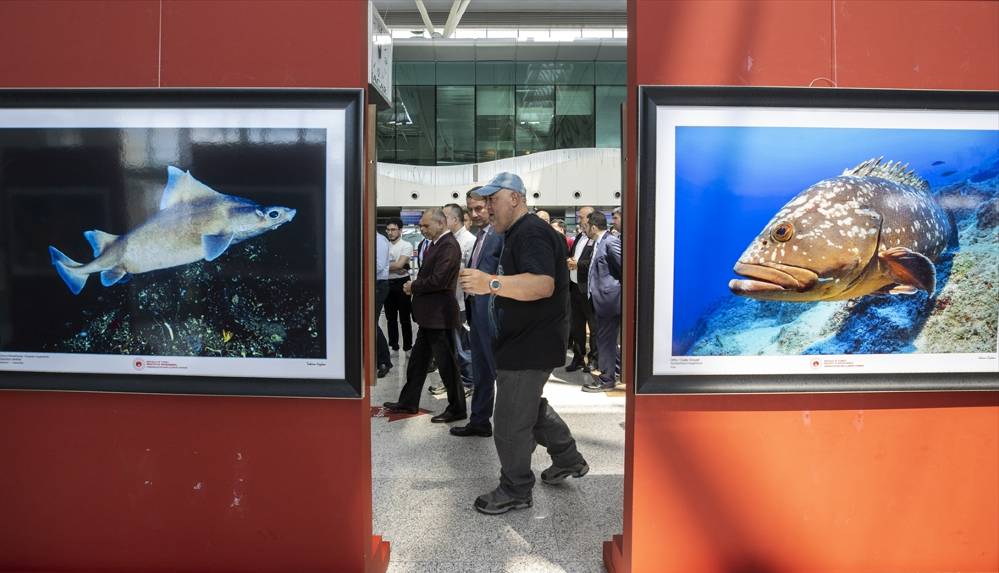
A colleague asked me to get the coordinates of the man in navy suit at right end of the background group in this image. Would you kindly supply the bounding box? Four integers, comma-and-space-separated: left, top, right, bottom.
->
583, 211, 621, 392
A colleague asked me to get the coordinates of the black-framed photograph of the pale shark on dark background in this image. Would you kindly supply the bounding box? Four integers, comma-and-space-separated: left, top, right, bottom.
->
0, 89, 363, 398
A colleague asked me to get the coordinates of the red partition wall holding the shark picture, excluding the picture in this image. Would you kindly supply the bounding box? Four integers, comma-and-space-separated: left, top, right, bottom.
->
0, 0, 388, 572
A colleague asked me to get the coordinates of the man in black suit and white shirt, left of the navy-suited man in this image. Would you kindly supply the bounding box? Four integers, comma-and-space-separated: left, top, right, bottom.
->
565, 207, 597, 372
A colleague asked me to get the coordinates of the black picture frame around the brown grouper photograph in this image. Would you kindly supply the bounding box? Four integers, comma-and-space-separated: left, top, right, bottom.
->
635, 86, 999, 395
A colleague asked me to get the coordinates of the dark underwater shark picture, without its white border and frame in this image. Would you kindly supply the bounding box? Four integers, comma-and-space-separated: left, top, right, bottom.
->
0, 129, 326, 358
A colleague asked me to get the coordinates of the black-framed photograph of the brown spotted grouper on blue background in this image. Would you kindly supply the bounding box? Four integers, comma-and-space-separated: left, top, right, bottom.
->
637, 87, 999, 394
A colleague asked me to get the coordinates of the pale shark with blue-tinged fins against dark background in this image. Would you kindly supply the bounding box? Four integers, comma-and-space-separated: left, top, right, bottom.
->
49, 166, 295, 294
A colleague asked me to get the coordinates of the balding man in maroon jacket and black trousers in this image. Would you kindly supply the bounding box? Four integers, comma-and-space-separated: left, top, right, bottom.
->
384, 209, 468, 423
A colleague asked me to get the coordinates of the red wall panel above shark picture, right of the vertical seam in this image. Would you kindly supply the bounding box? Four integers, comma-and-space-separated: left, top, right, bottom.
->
163, 0, 368, 87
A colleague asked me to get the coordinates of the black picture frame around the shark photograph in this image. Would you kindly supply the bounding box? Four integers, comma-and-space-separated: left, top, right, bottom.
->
0, 89, 364, 398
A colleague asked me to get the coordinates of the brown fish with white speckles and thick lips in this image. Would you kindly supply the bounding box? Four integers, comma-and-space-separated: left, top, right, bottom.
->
728, 158, 956, 302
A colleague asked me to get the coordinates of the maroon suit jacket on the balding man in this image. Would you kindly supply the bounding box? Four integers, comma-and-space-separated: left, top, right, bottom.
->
411, 233, 461, 328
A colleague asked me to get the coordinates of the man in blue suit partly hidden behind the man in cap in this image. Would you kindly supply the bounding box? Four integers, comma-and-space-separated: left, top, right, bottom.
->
451, 187, 503, 438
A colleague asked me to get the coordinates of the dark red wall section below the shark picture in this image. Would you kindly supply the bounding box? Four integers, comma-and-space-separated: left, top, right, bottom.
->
0, 392, 371, 571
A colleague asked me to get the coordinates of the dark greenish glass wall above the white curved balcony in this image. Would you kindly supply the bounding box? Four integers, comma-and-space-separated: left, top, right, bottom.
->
376, 61, 627, 165
